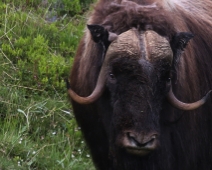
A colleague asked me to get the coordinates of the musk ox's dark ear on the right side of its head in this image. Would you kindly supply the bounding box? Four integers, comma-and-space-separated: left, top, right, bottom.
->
171, 32, 194, 65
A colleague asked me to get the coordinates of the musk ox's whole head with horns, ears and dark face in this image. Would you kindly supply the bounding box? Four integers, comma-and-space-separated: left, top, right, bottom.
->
68, 25, 208, 156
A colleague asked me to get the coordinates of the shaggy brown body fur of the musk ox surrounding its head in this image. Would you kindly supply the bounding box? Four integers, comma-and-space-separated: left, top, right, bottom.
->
70, 0, 212, 170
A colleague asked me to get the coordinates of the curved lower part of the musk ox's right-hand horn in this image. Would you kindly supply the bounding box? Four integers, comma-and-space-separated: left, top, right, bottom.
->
167, 86, 212, 110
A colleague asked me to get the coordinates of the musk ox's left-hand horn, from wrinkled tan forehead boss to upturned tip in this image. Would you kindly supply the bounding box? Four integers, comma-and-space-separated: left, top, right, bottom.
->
67, 29, 139, 104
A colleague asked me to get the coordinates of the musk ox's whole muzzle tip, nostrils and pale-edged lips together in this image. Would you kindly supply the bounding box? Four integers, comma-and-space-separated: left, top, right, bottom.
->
120, 132, 159, 156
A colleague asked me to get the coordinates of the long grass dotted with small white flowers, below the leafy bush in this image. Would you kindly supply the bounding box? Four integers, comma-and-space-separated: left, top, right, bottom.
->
0, 87, 91, 169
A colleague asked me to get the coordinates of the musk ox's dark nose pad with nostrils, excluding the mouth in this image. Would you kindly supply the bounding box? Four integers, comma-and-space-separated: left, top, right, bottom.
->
126, 132, 158, 149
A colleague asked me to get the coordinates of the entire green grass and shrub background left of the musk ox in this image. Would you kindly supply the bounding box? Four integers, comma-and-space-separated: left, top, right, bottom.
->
0, 0, 95, 170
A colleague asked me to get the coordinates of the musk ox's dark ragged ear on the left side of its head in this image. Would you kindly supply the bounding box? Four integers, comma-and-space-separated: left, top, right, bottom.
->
87, 25, 117, 47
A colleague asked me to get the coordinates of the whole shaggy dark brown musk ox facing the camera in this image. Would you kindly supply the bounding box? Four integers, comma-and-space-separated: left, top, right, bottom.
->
67, 0, 212, 170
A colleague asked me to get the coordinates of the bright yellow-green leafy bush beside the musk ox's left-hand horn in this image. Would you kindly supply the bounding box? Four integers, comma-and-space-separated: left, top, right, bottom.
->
2, 35, 67, 91
